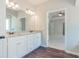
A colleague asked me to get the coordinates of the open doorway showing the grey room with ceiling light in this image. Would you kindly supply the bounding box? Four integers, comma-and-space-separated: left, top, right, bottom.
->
48, 10, 65, 50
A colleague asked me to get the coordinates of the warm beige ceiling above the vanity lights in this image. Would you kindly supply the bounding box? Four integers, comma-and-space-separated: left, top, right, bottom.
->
9, 0, 48, 6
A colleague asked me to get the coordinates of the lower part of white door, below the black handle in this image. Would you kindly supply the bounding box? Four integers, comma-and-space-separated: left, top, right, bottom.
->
0, 38, 7, 58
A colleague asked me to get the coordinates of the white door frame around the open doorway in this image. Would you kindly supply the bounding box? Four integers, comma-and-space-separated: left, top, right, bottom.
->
46, 8, 67, 50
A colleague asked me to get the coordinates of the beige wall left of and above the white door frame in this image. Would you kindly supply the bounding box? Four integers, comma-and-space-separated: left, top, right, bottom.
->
36, 0, 74, 46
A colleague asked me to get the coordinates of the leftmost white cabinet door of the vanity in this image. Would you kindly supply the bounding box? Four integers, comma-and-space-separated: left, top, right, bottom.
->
8, 38, 17, 58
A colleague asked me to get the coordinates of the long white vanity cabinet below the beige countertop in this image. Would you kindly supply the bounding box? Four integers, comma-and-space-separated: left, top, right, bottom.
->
8, 33, 41, 58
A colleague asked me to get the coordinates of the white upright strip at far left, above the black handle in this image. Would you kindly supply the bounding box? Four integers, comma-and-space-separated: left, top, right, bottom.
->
0, 0, 6, 36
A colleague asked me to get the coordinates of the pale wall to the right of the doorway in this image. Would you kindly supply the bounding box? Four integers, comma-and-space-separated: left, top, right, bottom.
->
66, 0, 79, 55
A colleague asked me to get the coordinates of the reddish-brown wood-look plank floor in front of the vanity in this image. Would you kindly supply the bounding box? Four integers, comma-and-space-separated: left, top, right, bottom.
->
23, 47, 78, 58
